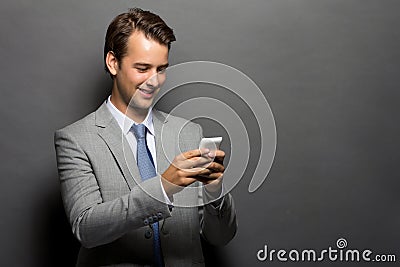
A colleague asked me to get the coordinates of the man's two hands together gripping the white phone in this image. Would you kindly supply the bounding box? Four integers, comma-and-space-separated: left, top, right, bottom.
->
161, 149, 225, 196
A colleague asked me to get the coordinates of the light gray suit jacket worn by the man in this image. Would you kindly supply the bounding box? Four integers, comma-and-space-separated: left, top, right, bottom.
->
55, 104, 237, 266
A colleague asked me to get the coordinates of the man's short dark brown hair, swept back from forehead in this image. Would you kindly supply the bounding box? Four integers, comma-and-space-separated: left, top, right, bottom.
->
104, 8, 176, 75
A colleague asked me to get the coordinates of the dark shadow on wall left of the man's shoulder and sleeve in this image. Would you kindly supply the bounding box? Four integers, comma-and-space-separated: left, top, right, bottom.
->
30, 74, 111, 267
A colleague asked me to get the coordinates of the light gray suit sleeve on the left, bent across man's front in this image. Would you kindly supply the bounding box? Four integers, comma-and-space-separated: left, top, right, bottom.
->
55, 130, 171, 248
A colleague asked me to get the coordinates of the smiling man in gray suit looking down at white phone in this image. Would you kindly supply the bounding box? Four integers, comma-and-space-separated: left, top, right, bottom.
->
55, 8, 236, 266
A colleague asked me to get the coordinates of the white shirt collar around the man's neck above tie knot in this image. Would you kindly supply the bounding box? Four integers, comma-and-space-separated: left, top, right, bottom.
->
106, 96, 154, 135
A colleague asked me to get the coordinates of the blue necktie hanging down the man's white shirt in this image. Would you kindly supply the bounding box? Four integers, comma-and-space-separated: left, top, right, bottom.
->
132, 124, 164, 266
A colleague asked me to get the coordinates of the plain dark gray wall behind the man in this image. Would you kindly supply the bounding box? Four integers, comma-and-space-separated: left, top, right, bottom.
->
0, 0, 400, 266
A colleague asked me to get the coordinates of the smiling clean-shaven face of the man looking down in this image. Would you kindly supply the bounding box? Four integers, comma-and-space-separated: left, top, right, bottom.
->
111, 31, 168, 114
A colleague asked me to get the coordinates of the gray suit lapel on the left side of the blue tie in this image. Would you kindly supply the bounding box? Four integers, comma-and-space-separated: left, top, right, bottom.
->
95, 103, 140, 189
